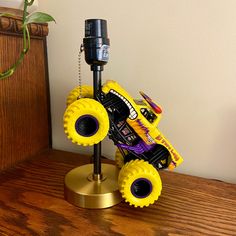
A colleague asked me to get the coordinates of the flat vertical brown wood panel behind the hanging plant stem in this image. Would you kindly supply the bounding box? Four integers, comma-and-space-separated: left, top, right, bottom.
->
0, 24, 50, 170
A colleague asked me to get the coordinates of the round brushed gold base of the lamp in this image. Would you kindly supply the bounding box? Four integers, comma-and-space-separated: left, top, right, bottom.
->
64, 164, 122, 208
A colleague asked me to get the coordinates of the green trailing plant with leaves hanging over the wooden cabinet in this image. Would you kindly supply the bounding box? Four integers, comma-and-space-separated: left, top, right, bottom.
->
0, 0, 55, 80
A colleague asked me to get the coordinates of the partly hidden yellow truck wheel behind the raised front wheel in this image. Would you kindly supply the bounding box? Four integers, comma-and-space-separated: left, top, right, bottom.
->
66, 85, 93, 106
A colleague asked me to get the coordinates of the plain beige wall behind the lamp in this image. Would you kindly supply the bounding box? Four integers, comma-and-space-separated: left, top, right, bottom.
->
40, 0, 236, 183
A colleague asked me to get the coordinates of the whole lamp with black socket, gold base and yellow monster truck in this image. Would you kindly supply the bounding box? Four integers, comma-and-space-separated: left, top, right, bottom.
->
64, 19, 183, 208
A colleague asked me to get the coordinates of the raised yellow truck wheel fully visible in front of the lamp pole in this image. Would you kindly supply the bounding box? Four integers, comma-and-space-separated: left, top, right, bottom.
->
64, 98, 109, 146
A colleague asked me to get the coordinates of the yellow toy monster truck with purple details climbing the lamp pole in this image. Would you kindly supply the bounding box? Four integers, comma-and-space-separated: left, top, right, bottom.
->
64, 80, 183, 207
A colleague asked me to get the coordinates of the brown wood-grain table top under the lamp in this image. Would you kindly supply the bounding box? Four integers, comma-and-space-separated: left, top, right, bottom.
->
0, 150, 236, 236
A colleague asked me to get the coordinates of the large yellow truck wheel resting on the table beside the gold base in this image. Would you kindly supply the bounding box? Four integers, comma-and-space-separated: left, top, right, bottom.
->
118, 160, 162, 207
